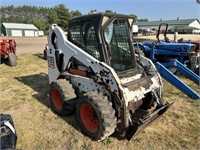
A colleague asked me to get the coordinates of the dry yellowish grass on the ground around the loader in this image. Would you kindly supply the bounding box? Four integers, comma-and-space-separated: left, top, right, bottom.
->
0, 55, 200, 150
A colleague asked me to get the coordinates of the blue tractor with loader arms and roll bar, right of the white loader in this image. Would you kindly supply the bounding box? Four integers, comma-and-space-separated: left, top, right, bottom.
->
134, 24, 200, 100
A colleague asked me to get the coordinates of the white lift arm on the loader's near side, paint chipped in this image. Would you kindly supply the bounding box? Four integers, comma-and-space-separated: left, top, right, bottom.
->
47, 25, 122, 92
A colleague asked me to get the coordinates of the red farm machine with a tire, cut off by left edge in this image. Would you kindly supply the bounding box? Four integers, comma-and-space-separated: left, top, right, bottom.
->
0, 38, 17, 67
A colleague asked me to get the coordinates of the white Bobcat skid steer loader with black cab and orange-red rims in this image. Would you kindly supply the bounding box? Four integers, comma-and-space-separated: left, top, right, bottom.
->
47, 13, 171, 141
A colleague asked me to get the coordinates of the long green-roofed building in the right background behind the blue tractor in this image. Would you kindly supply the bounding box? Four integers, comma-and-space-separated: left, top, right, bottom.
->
135, 18, 200, 34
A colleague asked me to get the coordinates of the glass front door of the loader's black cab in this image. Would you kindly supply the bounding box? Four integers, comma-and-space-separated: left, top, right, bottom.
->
103, 18, 136, 74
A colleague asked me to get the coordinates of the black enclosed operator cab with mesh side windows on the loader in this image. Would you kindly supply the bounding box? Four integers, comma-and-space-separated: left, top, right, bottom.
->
68, 13, 136, 74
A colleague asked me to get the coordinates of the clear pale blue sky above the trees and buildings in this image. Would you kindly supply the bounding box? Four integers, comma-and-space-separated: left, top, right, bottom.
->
0, 0, 200, 21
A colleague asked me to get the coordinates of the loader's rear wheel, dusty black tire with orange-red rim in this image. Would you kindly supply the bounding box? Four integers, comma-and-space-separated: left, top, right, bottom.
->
50, 79, 76, 116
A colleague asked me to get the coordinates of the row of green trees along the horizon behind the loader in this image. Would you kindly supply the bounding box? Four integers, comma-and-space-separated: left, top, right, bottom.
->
0, 4, 148, 32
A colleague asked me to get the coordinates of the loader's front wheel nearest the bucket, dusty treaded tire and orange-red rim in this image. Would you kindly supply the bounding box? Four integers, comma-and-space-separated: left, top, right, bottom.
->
76, 91, 117, 141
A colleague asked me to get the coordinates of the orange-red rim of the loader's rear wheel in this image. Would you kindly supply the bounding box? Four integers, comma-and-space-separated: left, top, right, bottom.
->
52, 88, 62, 110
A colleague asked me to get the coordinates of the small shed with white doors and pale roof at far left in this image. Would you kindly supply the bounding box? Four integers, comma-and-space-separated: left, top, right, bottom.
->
1, 23, 38, 37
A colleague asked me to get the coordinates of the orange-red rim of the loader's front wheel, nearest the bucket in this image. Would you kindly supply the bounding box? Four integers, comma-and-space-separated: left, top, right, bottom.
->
80, 103, 99, 133
